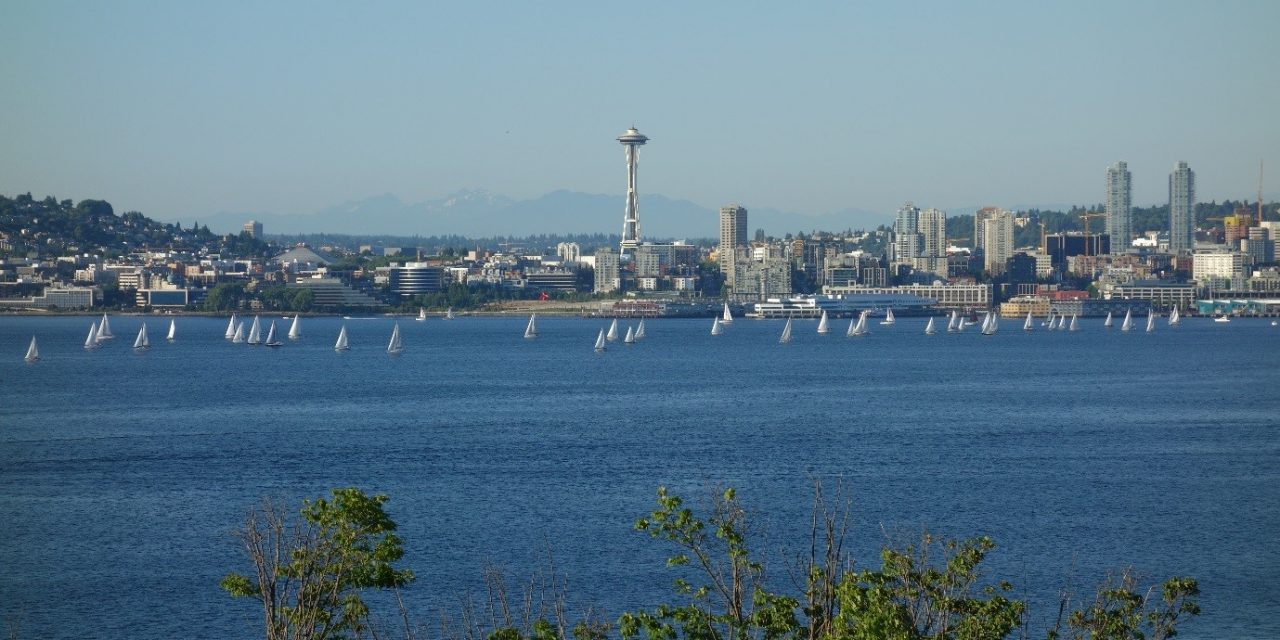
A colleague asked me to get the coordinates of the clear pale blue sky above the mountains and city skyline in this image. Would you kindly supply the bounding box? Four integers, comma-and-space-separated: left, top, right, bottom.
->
0, 0, 1280, 226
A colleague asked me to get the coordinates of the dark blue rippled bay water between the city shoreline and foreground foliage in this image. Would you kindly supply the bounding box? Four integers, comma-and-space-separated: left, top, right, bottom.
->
0, 316, 1280, 639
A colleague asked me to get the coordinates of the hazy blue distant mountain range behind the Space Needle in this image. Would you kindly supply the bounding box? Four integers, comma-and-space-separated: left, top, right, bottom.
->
189, 189, 892, 239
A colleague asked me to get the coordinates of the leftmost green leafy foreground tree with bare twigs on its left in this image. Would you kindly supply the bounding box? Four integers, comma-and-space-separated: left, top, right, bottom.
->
221, 488, 413, 640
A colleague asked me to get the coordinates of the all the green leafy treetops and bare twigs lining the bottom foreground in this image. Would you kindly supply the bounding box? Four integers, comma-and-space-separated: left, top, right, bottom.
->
223, 485, 1199, 640
